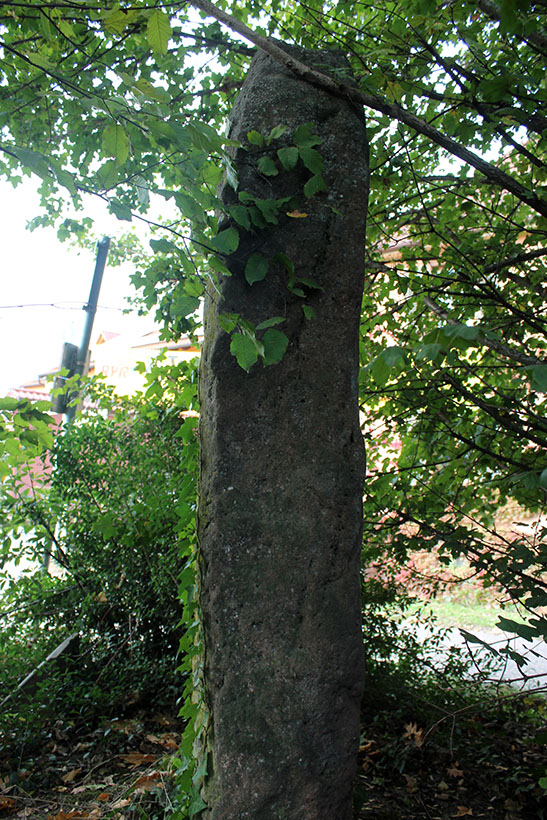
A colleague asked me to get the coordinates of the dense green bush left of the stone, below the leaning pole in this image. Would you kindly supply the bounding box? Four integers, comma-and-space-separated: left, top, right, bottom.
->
0, 363, 197, 737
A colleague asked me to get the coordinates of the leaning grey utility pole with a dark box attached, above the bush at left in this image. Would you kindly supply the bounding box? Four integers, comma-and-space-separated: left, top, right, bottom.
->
52, 236, 110, 424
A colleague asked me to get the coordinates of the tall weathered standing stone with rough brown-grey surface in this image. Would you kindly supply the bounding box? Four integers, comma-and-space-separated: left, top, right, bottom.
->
199, 44, 368, 820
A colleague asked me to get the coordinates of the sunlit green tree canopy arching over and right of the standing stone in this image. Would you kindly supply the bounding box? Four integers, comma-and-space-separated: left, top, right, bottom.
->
0, 0, 547, 811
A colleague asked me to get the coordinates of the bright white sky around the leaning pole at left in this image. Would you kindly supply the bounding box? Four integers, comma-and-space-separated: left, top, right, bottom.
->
0, 176, 153, 396
